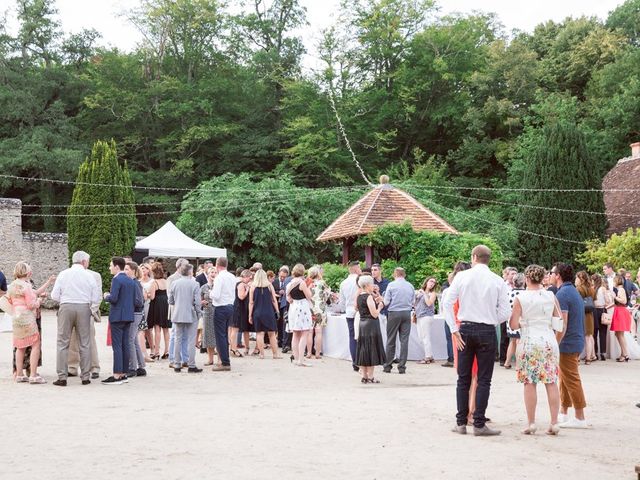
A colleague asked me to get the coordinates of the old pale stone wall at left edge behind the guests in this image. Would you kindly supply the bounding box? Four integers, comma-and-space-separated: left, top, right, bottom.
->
0, 198, 69, 292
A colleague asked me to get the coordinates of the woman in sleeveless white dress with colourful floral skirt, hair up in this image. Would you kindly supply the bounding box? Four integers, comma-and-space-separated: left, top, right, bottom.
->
509, 265, 561, 435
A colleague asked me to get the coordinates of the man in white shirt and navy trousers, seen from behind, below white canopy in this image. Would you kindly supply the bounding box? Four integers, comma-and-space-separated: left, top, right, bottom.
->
209, 257, 236, 372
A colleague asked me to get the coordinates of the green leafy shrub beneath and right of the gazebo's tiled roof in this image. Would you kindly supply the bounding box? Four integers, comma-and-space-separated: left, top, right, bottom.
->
359, 224, 503, 287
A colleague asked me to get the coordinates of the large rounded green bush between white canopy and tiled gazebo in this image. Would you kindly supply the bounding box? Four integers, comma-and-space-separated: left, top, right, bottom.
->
178, 173, 359, 271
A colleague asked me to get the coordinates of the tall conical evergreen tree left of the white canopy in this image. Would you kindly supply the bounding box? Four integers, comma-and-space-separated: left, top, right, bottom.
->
67, 140, 137, 289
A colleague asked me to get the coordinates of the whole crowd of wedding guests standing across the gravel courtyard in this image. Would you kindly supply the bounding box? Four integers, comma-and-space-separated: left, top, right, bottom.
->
0, 245, 639, 430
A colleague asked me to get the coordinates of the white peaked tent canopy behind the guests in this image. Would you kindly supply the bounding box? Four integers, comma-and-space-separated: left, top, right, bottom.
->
135, 222, 227, 258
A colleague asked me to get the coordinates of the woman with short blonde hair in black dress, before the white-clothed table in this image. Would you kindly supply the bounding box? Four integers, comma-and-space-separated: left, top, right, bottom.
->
356, 275, 387, 383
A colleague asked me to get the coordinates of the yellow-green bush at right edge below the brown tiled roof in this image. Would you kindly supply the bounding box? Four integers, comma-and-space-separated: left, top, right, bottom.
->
578, 228, 640, 272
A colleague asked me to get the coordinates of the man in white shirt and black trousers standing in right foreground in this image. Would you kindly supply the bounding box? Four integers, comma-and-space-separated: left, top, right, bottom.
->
443, 245, 511, 436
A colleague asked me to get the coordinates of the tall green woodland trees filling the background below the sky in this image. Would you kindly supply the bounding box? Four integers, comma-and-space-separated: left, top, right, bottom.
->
0, 0, 640, 263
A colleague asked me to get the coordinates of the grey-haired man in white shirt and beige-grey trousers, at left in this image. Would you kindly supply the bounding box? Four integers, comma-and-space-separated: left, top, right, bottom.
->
51, 251, 102, 387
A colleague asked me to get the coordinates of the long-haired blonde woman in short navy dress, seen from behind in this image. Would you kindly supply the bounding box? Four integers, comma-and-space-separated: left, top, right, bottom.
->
249, 268, 282, 359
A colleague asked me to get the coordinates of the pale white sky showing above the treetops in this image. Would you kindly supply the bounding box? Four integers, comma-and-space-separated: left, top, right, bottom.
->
0, 0, 624, 68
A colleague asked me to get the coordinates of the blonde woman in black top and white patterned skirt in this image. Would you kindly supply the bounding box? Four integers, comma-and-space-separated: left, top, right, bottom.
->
287, 263, 313, 367
